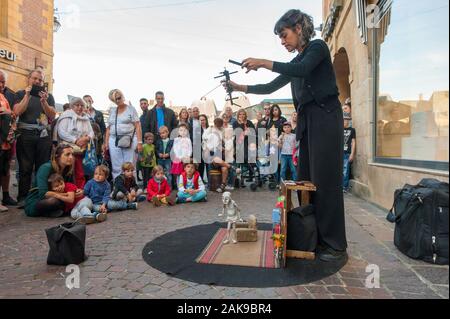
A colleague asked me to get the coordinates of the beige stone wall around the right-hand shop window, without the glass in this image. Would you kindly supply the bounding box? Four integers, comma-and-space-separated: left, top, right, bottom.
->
323, 0, 448, 208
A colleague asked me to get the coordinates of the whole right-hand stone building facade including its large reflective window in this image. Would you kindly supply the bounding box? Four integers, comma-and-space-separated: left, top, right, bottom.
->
322, 0, 449, 208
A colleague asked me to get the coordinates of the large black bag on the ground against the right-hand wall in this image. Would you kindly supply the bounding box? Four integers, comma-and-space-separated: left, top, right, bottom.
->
387, 179, 449, 265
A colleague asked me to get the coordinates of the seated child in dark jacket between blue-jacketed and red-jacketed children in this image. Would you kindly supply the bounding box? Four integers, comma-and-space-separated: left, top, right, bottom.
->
111, 162, 145, 203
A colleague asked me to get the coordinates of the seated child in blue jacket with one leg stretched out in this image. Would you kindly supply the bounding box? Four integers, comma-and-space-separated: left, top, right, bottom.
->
84, 165, 138, 214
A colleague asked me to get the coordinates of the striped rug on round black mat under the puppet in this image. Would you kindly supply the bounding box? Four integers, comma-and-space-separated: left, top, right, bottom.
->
196, 228, 276, 269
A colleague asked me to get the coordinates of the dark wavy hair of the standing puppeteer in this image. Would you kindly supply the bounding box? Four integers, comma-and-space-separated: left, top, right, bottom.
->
274, 9, 316, 47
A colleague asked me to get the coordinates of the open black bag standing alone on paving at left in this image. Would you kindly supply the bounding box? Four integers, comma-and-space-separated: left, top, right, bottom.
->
45, 222, 87, 266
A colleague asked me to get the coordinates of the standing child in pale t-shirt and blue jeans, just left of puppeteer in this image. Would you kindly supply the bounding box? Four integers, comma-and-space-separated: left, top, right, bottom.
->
279, 121, 297, 181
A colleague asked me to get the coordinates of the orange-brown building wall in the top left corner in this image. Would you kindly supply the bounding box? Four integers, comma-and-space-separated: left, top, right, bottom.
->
0, 0, 54, 92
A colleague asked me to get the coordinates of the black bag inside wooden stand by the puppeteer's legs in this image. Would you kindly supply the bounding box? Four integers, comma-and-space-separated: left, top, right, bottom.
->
287, 205, 318, 252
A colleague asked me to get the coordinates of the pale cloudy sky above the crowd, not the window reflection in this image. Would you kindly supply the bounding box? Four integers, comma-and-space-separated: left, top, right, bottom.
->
54, 0, 322, 110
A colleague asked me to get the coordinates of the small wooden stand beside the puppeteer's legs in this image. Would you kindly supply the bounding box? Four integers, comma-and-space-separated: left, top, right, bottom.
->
281, 182, 317, 267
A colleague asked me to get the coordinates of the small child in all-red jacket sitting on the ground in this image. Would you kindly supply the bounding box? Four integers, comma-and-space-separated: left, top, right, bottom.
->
147, 165, 176, 207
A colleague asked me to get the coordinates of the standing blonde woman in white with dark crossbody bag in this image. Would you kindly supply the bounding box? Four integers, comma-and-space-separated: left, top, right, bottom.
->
103, 90, 142, 179
